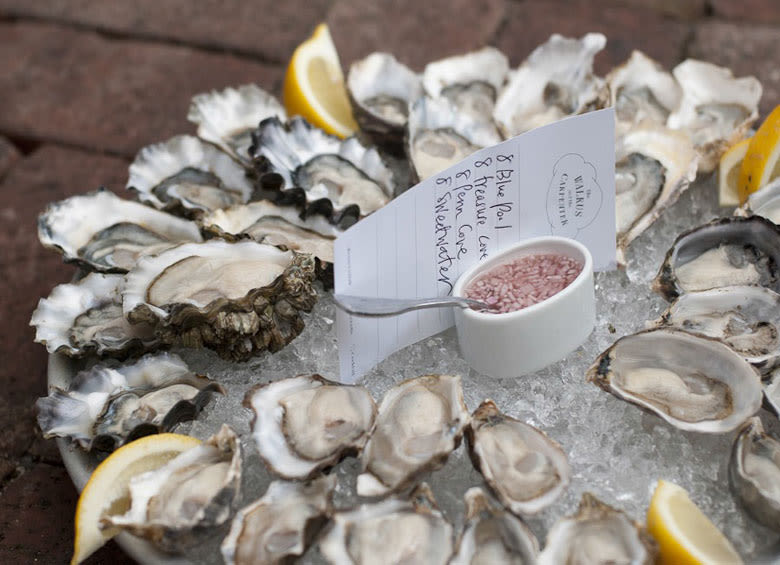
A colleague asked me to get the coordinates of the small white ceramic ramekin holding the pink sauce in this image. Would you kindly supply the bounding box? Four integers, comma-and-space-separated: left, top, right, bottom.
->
452, 236, 596, 377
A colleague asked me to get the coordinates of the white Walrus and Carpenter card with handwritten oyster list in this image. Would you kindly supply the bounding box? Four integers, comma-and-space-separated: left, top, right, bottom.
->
334, 108, 615, 383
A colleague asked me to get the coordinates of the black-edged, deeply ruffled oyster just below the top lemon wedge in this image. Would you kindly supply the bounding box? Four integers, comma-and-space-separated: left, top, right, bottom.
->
250, 117, 396, 223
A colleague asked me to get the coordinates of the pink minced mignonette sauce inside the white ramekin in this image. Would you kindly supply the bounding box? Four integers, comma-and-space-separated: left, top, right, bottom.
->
464, 253, 582, 314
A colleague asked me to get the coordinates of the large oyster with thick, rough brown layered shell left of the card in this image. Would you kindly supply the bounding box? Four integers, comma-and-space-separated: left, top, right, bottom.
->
122, 240, 317, 360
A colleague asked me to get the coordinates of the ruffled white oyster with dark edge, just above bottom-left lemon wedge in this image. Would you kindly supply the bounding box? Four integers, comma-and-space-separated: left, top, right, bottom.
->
35, 353, 224, 451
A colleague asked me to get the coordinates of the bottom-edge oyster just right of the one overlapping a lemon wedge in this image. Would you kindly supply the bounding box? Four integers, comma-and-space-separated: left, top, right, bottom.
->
221, 475, 336, 565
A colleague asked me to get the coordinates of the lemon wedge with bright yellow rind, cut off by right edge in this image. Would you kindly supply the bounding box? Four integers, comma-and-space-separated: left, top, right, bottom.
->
738, 106, 780, 203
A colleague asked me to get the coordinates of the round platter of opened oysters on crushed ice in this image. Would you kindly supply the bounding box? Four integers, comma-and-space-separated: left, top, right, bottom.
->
31, 33, 780, 564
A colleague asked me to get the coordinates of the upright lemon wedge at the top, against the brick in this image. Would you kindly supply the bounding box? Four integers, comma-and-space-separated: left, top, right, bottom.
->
283, 24, 358, 137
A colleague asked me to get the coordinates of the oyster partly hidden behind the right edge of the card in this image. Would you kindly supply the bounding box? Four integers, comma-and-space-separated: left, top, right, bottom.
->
615, 121, 698, 264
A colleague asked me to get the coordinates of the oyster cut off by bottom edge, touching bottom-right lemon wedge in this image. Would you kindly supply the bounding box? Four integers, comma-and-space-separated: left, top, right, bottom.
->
537, 492, 658, 565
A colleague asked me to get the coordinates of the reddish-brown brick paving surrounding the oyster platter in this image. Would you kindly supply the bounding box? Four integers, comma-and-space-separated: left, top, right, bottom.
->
0, 0, 780, 565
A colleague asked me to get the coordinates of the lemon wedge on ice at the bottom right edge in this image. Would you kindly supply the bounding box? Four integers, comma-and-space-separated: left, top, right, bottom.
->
647, 481, 742, 565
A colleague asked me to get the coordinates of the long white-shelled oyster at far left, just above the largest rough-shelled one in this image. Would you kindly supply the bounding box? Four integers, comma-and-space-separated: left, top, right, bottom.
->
38, 189, 203, 273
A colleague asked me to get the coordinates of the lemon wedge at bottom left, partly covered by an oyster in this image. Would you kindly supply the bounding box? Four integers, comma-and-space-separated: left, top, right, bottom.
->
70, 434, 200, 565
